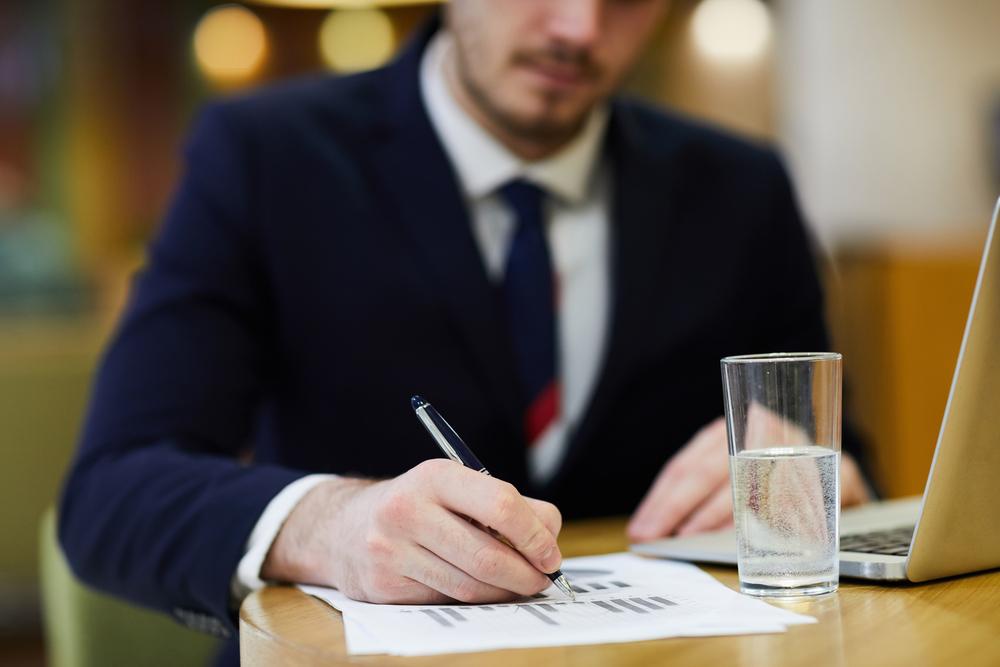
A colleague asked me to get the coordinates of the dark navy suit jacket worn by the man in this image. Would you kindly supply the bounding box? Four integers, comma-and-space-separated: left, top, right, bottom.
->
60, 22, 860, 656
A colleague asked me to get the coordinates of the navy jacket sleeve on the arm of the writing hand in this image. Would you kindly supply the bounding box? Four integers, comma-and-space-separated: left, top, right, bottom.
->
59, 105, 303, 635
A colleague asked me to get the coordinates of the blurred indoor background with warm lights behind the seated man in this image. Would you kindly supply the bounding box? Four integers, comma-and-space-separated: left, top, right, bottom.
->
0, 0, 1000, 665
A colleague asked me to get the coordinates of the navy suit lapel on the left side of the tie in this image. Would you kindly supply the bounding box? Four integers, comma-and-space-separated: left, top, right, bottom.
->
370, 25, 521, 446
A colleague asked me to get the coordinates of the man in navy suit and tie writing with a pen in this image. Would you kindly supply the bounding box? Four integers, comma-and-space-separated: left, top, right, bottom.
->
60, 0, 864, 656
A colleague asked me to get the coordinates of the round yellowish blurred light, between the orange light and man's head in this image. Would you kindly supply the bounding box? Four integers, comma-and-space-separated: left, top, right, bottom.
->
319, 8, 396, 72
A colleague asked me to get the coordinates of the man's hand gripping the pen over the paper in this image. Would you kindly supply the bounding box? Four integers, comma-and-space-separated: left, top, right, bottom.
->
261, 459, 562, 604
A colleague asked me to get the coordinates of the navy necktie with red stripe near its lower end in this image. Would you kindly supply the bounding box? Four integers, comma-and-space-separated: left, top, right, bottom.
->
500, 179, 560, 445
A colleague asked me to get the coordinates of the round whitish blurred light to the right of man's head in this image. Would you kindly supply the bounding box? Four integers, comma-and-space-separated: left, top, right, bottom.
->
691, 0, 771, 62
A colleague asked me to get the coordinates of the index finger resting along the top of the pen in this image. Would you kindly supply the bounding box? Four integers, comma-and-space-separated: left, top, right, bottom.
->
417, 459, 562, 572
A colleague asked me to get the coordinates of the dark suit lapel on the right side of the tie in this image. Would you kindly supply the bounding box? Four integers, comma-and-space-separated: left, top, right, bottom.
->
549, 104, 678, 485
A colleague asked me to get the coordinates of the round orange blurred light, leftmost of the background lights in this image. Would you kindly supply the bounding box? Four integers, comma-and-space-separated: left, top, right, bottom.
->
194, 5, 267, 86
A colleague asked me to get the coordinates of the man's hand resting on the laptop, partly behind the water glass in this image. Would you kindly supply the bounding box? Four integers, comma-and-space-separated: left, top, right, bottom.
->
628, 417, 869, 542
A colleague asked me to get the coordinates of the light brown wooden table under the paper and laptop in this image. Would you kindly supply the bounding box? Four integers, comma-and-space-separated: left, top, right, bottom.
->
240, 519, 1000, 667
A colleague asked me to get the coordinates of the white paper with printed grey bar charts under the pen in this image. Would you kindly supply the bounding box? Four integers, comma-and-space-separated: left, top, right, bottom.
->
300, 553, 816, 655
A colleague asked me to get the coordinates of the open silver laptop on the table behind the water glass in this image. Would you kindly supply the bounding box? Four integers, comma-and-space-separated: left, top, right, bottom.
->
631, 200, 1000, 582
